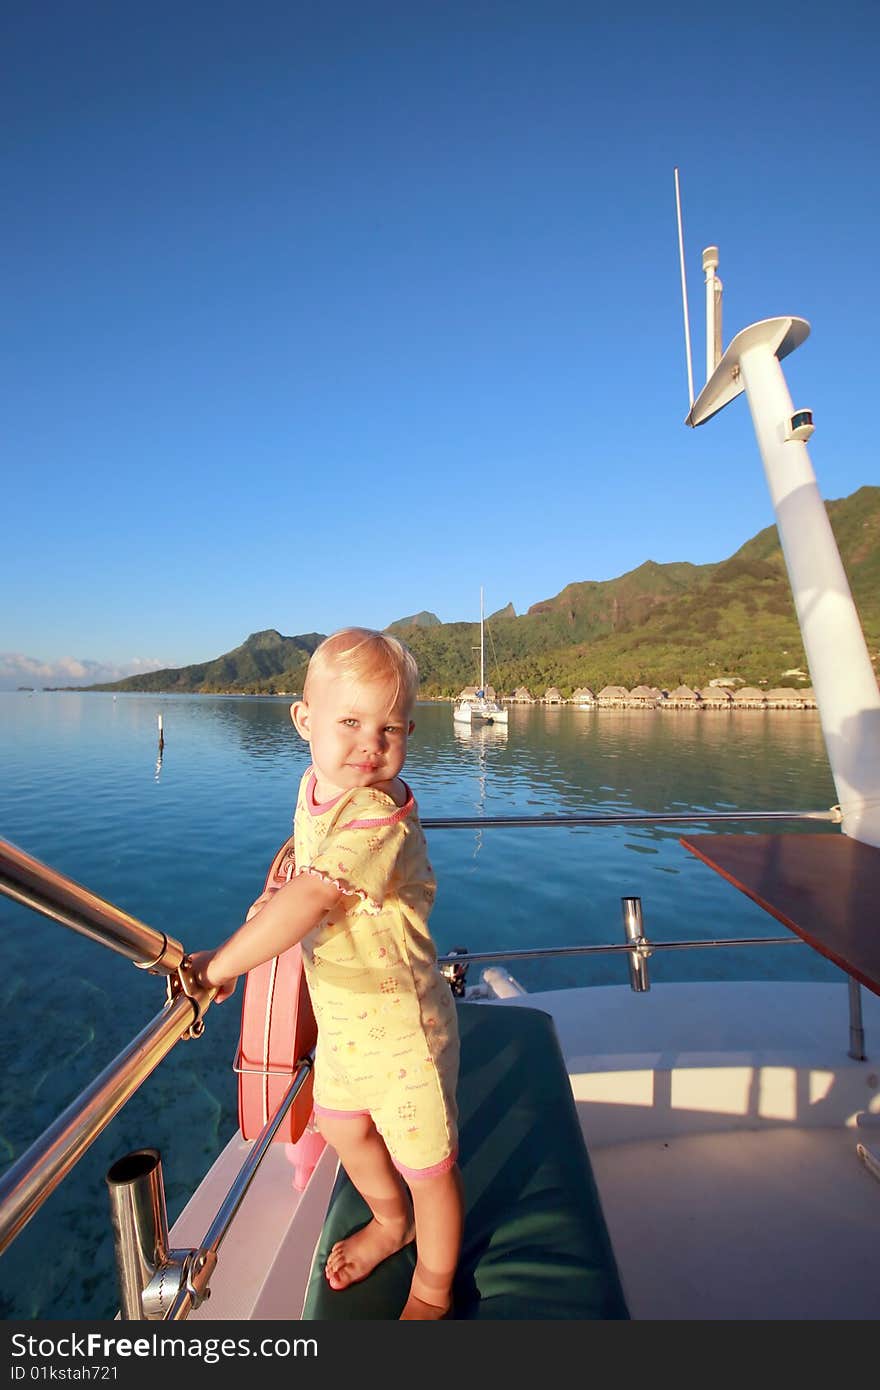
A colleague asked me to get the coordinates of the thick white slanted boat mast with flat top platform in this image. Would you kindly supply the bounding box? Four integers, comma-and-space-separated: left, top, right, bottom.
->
685, 205, 880, 847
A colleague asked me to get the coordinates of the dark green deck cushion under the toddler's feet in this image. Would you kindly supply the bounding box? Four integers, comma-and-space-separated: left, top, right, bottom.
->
303, 1004, 628, 1321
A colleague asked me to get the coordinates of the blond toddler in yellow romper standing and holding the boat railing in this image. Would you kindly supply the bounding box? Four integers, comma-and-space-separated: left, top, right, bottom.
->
192, 628, 463, 1319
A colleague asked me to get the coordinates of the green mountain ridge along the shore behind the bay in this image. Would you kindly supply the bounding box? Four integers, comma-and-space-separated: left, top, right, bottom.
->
90, 487, 880, 696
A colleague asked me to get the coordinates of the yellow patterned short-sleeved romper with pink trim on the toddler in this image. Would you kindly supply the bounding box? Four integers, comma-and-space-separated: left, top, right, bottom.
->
293, 767, 459, 1177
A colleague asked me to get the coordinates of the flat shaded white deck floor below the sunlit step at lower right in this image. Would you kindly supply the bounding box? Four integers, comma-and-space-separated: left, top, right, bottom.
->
594, 1127, 880, 1321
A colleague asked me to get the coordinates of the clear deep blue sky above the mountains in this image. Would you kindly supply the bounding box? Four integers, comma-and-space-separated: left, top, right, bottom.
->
0, 0, 880, 687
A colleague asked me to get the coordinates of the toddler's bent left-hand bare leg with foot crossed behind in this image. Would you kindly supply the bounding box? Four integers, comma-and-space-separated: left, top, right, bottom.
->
317, 1113, 413, 1289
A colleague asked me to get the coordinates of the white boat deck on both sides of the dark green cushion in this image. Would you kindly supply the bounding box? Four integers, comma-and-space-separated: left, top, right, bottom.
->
172, 983, 880, 1321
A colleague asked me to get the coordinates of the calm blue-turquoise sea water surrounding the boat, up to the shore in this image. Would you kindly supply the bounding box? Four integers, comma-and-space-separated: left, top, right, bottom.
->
0, 692, 840, 1318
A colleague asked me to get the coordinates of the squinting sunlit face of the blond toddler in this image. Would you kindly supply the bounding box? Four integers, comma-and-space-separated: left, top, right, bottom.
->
291, 669, 416, 801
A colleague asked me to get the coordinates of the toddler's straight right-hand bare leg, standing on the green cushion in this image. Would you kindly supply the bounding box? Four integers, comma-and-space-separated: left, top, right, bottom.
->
400, 1165, 464, 1322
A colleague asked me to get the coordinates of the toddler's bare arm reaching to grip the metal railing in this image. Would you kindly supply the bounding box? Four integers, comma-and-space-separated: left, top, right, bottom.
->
190, 874, 341, 1004
